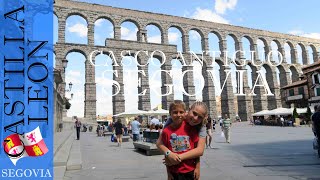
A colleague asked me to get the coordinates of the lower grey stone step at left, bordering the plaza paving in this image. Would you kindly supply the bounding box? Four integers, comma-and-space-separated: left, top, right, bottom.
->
67, 140, 82, 171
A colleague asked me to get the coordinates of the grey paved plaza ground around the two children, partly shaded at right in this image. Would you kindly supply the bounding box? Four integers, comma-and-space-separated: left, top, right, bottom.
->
64, 122, 320, 180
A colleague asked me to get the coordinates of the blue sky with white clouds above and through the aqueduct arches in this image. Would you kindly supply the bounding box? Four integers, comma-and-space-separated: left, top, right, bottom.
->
58, 0, 320, 116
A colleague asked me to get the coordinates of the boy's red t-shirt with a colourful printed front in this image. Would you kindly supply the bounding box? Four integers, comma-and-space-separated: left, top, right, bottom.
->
161, 121, 199, 173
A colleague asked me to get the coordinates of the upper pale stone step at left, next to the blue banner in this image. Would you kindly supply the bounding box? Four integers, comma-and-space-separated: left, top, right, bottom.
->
53, 133, 75, 166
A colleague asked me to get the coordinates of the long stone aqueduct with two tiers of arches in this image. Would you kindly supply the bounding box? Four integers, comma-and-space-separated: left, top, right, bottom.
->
54, 0, 320, 119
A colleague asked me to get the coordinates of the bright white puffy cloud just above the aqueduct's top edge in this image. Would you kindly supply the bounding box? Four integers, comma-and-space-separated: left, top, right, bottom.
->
191, 7, 229, 24
